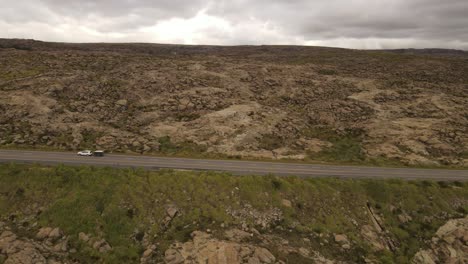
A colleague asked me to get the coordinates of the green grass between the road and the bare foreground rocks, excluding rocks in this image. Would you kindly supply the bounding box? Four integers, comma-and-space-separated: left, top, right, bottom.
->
0, 164, 468, 263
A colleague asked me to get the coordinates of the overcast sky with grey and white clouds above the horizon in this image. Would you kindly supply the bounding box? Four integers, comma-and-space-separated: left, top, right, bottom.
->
0, 0, 468, 50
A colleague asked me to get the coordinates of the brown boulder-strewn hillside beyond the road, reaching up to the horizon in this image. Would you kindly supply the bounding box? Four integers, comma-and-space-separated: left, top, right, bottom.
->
0, 39, 468, 167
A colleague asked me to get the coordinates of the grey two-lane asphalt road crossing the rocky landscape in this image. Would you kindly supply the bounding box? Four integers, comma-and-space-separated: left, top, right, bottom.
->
0, 150, 468, 181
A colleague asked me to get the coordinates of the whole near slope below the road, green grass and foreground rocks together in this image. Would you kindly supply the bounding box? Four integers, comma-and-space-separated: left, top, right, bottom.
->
0, 164, 468, 264
